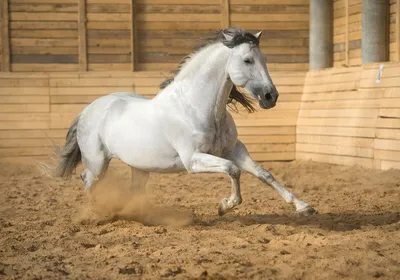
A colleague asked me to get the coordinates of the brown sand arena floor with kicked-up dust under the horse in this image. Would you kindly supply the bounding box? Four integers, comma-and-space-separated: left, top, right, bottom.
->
0, 159, 400, 279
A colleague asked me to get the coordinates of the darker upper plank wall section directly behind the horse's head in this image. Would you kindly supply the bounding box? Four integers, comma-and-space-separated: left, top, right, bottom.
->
136, 0, 309, 71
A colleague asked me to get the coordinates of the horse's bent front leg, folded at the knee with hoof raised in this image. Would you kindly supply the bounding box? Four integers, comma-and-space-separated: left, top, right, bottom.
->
189, 153, 242, 216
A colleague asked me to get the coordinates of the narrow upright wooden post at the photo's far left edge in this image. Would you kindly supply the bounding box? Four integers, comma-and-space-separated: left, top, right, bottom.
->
0, 0, 10, 72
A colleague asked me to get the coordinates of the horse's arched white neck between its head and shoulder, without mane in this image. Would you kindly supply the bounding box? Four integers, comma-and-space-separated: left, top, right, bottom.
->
170, 43, 233, 120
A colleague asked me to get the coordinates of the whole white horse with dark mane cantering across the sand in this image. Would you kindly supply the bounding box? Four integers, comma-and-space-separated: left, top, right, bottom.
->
45, 27, 316, 216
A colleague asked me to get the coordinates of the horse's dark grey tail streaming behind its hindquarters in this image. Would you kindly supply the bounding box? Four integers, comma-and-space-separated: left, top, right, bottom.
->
40, 115, 82, 179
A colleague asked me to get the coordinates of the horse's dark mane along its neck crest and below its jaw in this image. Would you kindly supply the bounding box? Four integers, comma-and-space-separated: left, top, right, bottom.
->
160, 27, 259, 113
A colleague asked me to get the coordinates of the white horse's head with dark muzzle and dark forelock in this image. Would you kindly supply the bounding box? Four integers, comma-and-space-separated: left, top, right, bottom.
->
222, 29, 279, 109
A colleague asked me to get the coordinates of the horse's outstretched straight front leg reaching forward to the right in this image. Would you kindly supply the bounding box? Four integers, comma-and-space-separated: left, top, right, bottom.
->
227, 141, 317, 216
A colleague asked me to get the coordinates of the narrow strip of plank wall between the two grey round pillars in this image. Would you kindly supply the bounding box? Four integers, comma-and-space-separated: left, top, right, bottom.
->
333, 0, 362, 67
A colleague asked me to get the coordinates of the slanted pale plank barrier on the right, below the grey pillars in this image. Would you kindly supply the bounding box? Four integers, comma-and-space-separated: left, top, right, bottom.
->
296, 63, 400, 169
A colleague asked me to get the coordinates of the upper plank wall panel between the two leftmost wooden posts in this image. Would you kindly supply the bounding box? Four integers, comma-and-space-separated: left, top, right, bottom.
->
9, 0, 79, 72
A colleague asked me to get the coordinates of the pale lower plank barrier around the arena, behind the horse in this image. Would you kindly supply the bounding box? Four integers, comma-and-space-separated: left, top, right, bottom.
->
0, 63, 400, 169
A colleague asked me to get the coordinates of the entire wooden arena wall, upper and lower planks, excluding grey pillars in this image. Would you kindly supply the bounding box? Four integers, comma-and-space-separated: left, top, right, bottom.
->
0, 0, 400, 169
